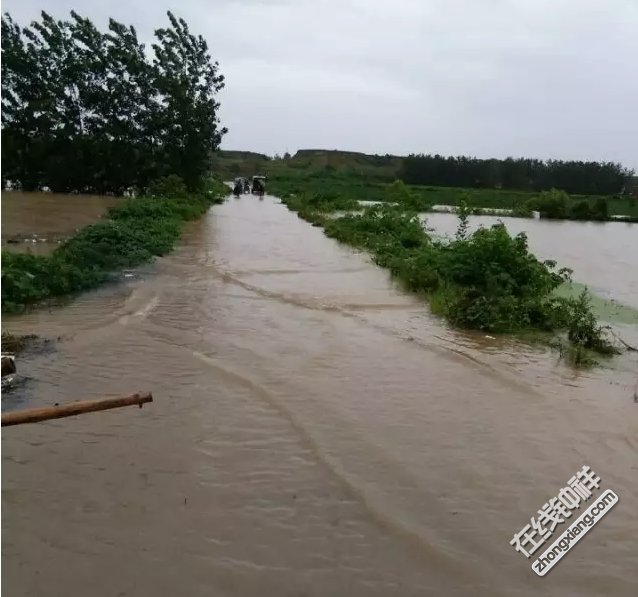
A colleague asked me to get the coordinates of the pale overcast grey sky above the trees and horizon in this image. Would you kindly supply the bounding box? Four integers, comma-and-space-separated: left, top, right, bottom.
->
2, 0, 638, 170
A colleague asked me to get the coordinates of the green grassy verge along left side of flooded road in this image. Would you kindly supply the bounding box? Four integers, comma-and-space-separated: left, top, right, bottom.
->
2, 177, 229, 312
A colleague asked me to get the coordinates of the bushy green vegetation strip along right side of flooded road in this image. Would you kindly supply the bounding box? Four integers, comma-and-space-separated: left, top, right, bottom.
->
284, 189, 618, 365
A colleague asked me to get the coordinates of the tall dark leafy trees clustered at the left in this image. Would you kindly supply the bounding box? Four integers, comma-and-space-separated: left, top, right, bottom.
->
2, 12, 225, 194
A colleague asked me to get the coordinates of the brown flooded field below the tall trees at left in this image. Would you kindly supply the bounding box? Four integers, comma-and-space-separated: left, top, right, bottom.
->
0, 191, 118, 254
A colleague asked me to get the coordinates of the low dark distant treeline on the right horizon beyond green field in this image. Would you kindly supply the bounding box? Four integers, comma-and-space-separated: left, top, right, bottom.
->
399, 154, 633, 195
